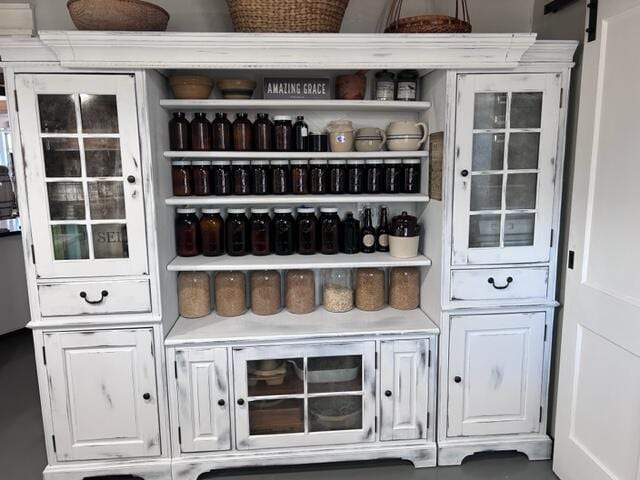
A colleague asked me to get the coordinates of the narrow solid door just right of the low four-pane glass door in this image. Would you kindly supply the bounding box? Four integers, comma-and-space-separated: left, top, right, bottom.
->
380, 339, 429, 441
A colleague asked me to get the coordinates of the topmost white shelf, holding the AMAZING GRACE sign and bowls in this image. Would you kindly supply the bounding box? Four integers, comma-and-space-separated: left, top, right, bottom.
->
160, 99, 431, 112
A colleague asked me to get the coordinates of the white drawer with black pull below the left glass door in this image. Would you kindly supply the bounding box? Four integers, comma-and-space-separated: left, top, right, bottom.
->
38, 280, 151, 317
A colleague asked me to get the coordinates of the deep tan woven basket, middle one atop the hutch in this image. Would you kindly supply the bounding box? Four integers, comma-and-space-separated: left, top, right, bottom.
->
227, 0, 349, 33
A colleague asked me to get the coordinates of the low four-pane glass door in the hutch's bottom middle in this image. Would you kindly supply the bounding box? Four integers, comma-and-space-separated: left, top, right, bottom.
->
233, 342, 375, 449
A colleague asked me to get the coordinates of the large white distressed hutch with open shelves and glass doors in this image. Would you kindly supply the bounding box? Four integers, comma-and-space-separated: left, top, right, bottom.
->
0, 32, 576, 480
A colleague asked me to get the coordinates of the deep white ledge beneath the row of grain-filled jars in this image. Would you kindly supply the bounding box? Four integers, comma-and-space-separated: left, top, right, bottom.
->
165, 306, 439, 345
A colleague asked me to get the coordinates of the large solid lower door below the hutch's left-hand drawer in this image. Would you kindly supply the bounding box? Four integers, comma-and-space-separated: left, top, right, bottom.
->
44, 329, 160, 461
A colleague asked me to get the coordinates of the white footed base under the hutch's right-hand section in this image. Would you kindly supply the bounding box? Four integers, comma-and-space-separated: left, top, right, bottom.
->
438, 435, 552, 465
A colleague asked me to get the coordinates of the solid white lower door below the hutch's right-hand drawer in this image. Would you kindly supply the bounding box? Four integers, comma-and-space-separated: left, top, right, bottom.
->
447, 312, 545, 437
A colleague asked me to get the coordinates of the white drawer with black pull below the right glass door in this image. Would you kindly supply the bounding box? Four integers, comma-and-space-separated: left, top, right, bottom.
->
449, 267, 549, 302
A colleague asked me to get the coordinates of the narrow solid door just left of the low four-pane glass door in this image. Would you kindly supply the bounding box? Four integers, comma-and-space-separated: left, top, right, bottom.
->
176, 348, 231, 452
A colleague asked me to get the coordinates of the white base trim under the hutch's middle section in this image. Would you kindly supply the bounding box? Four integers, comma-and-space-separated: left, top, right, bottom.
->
171, 443, 436, 480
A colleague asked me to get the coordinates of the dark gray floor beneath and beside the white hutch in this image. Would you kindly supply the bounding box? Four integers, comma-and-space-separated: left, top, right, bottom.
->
0, 330, 557, 480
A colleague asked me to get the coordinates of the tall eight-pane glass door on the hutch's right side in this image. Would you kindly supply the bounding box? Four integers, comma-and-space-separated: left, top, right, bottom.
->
453, 74, 561, 265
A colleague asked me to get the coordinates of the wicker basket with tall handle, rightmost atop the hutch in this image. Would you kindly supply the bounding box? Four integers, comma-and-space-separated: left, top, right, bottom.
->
385, 0, 471, 33
